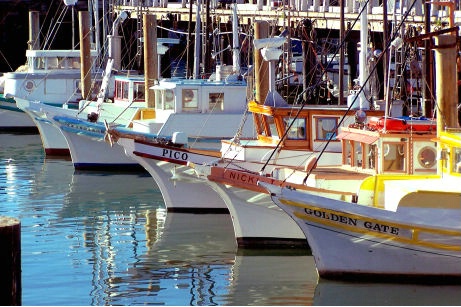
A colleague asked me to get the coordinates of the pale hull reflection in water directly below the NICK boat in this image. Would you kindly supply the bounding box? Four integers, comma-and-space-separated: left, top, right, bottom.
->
229, 248, 318, 306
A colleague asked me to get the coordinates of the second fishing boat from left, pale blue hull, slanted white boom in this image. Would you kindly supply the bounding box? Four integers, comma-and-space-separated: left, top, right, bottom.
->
15, 12, 131, 156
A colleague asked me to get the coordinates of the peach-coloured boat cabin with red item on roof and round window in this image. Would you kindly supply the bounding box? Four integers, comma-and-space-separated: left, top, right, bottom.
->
337, 117, 437, 175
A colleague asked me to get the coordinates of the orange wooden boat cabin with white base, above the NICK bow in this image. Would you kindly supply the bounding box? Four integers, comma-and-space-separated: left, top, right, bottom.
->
217, 101, 384, 166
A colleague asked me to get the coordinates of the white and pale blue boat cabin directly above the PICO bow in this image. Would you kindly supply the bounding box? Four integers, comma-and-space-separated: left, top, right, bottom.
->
127, 75, 253, 139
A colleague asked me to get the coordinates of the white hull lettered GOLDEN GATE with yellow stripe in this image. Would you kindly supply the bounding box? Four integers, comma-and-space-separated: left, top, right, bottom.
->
263, 184, 461, 281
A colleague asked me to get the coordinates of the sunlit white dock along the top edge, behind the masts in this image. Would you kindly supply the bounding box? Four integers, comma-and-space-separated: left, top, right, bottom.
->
114, 0, 461, 33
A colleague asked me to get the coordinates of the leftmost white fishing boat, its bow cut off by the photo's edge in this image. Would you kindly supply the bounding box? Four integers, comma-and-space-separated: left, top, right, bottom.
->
0, 6, 102, 134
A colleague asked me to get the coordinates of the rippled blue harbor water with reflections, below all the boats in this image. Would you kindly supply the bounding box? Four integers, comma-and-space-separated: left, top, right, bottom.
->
0, 134, 461, 306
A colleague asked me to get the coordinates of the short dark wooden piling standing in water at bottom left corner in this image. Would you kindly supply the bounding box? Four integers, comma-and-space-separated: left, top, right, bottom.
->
0, 216, 22, 306
